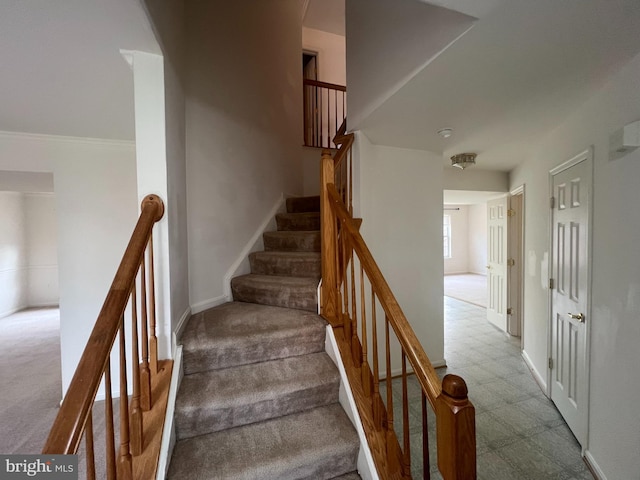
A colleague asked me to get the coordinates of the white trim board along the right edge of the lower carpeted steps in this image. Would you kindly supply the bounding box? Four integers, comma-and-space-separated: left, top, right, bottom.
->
324, 325, 379, 480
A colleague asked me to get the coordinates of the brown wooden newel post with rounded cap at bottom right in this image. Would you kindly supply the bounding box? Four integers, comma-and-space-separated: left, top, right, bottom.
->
436, 375, 476, 480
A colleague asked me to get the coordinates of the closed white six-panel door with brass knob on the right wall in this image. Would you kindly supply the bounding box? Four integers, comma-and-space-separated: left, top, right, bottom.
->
549, 152, 591, 445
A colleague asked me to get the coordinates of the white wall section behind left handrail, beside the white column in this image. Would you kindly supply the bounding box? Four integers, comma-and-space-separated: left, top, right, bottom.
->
53, 142, 138, 393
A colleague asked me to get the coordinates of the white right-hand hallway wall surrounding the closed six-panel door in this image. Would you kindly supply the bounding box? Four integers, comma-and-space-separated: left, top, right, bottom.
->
511, 50, 640, 480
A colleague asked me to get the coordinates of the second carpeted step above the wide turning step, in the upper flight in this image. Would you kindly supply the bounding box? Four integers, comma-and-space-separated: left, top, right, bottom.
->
249, 252, 322, 280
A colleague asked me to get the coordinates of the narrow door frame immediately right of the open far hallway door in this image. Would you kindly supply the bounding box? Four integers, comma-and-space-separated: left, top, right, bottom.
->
507, 184, 525, 349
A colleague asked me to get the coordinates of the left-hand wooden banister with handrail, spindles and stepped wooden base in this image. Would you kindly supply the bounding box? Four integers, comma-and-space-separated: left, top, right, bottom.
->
42, 195, 172, 479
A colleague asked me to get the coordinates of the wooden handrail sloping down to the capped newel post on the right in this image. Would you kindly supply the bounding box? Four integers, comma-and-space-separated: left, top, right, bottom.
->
327, 184, 442, 408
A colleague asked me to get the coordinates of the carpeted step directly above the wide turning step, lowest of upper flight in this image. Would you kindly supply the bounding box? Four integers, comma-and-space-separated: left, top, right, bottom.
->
231, 273, 318, 312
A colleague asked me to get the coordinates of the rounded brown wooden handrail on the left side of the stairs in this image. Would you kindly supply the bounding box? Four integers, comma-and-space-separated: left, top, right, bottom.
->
42, 195, 164, 454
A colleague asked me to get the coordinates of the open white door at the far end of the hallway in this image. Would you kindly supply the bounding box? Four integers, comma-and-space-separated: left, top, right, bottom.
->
487, 196, 508, 332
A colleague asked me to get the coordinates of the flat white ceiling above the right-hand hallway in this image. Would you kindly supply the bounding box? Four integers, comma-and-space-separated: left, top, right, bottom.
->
349, 0, 640, 171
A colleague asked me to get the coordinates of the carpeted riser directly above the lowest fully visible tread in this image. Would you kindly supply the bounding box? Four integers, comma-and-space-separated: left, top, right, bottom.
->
176, 381, 339, 439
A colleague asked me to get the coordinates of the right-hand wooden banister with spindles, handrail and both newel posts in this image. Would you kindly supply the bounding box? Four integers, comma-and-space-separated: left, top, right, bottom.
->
320, 128, 476, 480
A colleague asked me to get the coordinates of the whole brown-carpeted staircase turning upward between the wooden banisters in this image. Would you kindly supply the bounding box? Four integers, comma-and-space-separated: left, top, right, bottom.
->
169, 197, 360, 480
